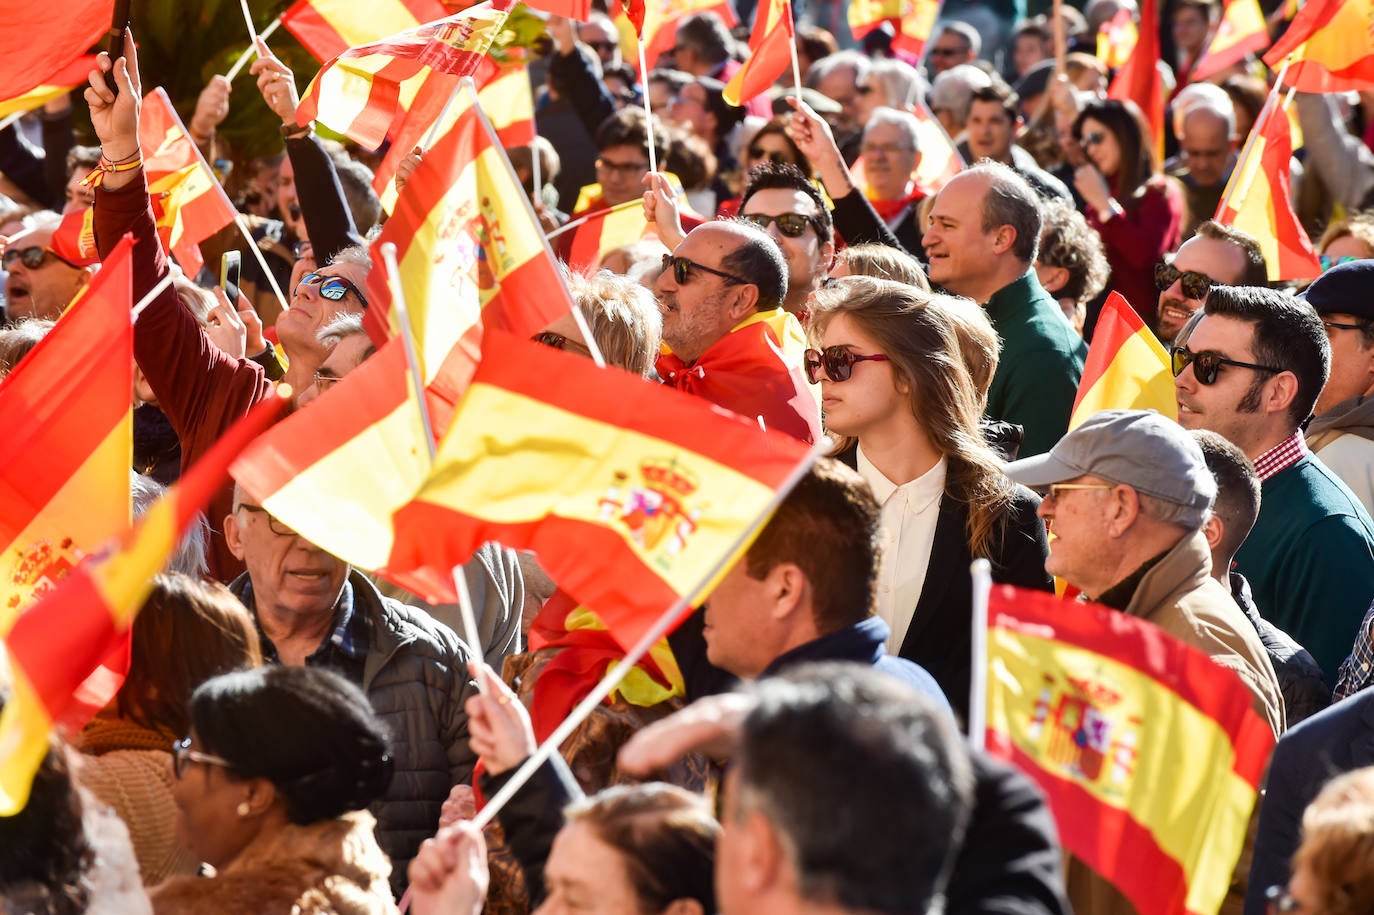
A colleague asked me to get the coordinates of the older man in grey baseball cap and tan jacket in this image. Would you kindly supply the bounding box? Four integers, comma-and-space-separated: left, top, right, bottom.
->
1007, 409, 1283, 912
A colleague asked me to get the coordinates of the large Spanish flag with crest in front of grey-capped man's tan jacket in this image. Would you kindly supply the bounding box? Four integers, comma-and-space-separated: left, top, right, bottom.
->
987, 585, 1274, 915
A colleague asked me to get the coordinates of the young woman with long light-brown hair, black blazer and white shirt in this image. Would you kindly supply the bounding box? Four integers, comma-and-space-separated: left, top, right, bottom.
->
807, 276, 1050, 719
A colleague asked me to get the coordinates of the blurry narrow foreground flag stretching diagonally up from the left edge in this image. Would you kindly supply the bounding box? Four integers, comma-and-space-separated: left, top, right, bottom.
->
0, 392, 284, 816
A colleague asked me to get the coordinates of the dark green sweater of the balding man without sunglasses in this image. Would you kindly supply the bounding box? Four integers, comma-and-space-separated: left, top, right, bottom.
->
985, 271, 1088, 458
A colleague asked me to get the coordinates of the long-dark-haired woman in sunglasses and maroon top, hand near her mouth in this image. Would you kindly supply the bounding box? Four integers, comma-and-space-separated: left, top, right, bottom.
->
1073, 99, 1183, 327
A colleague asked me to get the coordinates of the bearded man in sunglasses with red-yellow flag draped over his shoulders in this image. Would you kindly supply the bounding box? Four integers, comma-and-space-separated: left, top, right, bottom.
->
654, 220, 820, 442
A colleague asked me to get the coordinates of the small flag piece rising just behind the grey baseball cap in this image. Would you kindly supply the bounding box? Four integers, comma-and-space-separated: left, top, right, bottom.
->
1069, 293, 1179, 430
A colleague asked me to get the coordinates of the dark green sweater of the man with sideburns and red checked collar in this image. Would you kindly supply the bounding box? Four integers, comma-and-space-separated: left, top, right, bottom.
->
1235, 455, 1374, 686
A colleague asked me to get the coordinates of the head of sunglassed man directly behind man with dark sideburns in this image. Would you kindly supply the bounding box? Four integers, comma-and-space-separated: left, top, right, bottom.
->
1154, 220, 1270, 346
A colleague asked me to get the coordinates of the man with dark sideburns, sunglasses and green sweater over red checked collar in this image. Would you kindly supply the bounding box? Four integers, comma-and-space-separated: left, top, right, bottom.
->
1172, 286, 1374, 683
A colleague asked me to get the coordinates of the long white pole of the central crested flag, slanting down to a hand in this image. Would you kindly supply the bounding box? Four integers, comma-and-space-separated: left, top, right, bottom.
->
473, 436, 834, 828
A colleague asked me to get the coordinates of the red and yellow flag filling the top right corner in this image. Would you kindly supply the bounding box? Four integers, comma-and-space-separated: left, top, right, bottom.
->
1264, 0, 1374, 93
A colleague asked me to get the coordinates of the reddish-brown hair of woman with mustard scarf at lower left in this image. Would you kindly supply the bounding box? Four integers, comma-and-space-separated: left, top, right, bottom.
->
115, 573, 262, 738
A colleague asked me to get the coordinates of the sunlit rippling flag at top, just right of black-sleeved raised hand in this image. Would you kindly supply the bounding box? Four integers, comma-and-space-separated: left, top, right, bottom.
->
295, 0, 514, 153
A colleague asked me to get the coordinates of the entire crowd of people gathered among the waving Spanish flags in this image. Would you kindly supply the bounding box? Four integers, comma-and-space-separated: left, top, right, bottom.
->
0, 0, 1374, 915
